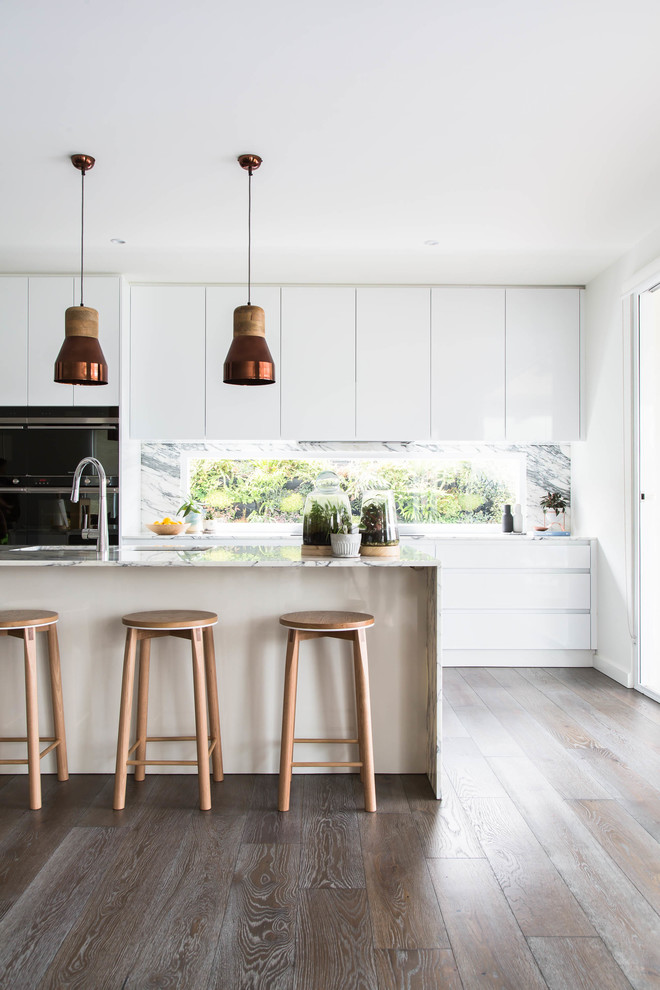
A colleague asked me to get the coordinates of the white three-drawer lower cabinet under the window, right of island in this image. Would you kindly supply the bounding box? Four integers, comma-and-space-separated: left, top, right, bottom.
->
435, 538, 596, 666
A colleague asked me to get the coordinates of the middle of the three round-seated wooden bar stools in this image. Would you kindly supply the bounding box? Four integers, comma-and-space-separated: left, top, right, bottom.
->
114, 609, 223, 811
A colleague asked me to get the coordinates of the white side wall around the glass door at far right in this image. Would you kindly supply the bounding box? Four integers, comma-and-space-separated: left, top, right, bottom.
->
572, 228, 660, 687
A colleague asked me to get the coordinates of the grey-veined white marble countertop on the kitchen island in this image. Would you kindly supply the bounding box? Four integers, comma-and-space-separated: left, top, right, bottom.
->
0, 543, 440, 567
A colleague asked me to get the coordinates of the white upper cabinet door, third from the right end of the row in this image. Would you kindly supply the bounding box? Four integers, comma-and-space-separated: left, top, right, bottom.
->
356, 289, 431, 440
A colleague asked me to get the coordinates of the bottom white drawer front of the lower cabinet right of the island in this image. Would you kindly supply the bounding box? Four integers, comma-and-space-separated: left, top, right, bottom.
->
442, 612, 591, 650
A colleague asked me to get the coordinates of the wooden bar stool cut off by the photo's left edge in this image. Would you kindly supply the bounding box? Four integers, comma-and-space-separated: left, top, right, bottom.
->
0, 608, 69, 811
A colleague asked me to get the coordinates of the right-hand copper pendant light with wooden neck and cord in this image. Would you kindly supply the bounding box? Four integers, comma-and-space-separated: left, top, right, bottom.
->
223, 155, 275, 385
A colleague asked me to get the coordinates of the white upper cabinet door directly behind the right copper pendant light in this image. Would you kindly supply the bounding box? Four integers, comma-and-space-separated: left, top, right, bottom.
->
206, 286, 282, 440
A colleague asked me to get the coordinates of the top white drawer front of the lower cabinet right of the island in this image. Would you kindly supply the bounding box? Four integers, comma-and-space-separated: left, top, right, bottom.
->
435, 548, 591, 570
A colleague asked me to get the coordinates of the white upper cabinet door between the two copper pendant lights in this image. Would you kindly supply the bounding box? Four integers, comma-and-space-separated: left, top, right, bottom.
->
130, 285, 206, 440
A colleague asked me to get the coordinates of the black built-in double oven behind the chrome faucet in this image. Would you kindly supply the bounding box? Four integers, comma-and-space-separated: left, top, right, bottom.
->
0, 406, 119, 546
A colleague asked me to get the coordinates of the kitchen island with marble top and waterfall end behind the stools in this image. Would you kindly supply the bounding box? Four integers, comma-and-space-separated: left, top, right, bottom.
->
0, 542, 441, 797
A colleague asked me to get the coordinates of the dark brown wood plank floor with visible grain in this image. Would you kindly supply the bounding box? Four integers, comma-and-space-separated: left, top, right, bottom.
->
0, 668, 660, 990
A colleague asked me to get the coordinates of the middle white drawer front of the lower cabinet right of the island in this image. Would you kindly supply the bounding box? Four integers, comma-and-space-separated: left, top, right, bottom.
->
442, 570, 591, 610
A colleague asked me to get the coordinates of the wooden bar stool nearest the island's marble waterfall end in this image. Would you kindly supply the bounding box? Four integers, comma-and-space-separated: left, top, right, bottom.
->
278, 612, 376, 811
